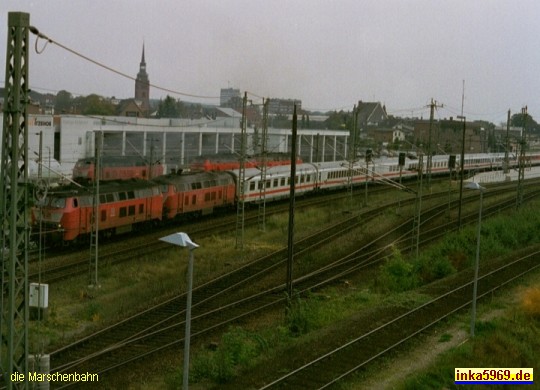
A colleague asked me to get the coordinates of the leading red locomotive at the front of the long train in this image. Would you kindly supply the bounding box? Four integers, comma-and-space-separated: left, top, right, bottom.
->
33, 180, 163, 243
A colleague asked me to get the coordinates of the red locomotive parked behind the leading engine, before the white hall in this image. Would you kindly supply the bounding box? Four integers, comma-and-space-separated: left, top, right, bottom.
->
73, 156, 163, 183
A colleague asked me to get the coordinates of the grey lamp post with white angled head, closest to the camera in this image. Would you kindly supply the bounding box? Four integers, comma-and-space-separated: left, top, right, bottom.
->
160, 233, 199, 390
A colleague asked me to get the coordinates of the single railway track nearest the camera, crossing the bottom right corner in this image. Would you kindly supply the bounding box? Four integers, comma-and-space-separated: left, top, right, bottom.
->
254, 250, 540, 390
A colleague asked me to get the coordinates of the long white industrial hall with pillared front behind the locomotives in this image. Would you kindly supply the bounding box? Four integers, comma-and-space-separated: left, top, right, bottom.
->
0, 114, 349, 180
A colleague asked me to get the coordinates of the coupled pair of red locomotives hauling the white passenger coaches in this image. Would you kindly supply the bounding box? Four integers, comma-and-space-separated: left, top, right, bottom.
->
33, 172, 236, 244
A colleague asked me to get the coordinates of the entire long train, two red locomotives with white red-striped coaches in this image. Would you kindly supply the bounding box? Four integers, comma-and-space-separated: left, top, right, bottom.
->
32, 153, 540, 244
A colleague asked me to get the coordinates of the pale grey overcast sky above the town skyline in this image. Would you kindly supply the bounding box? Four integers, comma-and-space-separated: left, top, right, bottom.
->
0, 0, 540, 124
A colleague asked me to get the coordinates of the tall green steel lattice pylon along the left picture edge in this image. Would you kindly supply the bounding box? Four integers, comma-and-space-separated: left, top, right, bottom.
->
0, 12, 30, 389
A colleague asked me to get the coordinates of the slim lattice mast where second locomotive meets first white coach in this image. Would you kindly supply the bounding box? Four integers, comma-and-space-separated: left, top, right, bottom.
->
236, 92, 248, 250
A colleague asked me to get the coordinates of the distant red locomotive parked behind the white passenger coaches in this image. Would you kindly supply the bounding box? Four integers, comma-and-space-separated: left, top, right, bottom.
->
190, 153, 302, 171
